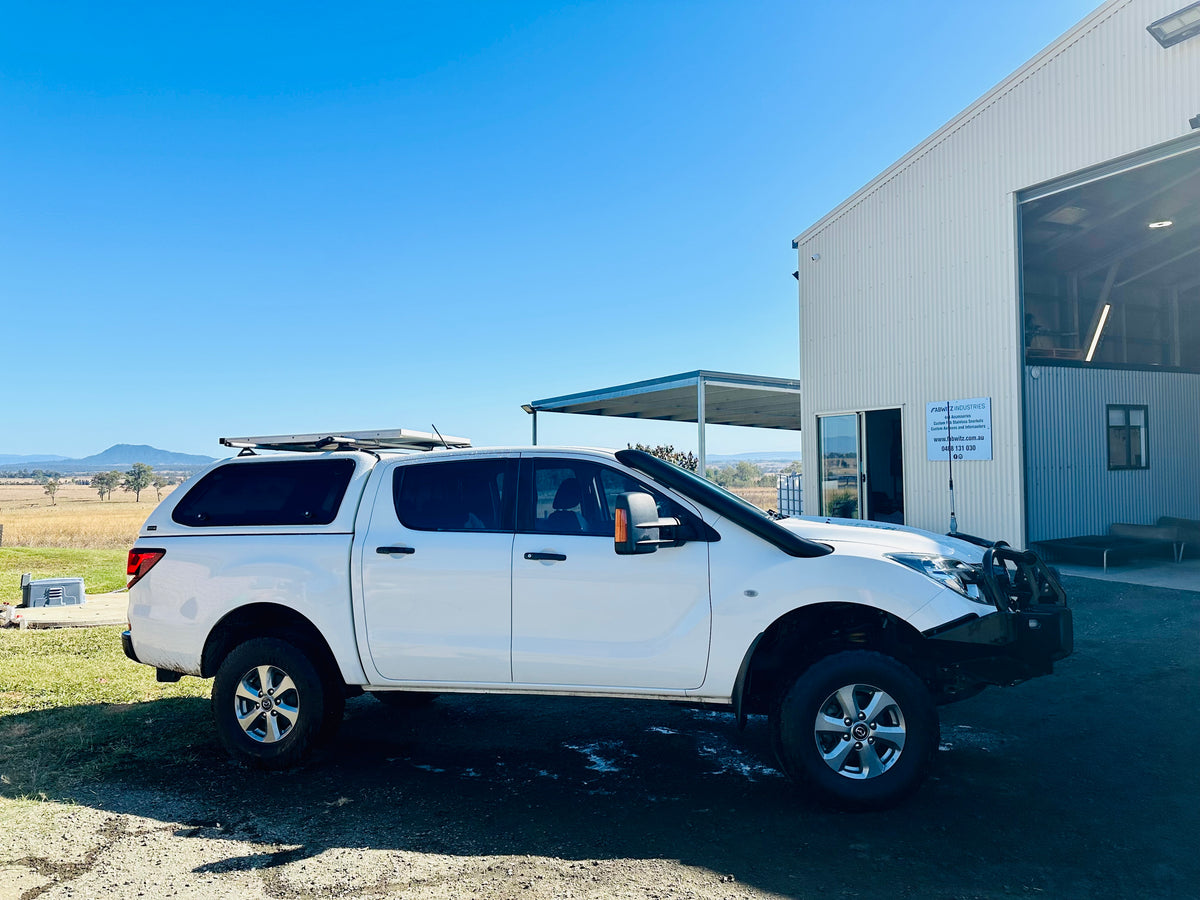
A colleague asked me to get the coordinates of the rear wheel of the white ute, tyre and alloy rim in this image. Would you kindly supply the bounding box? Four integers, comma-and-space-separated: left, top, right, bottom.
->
212, 637, 333, 769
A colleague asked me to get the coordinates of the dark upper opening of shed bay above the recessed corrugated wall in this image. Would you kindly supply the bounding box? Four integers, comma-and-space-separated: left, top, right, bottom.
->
1019, 139, 1200, 372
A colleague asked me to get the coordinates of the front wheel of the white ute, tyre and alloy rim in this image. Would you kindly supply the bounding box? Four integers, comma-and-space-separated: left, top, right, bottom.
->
772, 650, 938, 809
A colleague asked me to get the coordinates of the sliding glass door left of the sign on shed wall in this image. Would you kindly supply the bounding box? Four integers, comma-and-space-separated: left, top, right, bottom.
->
817, 409, 904, 524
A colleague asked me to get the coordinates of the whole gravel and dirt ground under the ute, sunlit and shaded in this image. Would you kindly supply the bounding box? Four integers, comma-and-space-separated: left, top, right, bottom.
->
0, 580, 1200, 900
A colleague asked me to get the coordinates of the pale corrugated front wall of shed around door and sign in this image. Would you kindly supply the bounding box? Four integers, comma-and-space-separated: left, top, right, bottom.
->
797, 0, 1200, 544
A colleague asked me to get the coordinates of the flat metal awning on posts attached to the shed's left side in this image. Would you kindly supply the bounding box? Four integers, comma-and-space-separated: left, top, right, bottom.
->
522, 368, 800, 473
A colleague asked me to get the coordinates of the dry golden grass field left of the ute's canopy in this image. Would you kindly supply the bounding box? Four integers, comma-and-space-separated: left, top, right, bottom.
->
0, 482, 172, 550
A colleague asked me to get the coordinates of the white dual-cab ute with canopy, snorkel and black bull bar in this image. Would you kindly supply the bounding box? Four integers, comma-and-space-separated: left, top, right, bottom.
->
122, 430, 1073, 808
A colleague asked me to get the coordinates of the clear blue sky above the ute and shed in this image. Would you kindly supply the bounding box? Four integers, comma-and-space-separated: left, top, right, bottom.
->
0, 0, 1094, 456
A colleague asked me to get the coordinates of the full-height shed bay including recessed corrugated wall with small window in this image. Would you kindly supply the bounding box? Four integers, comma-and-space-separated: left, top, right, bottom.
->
1018, 134, 1200, 544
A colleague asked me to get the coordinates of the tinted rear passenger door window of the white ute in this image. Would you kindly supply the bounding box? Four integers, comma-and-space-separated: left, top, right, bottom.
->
392, 458, 517, 532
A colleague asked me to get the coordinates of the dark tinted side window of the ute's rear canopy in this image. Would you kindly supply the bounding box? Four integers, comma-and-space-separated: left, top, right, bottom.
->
172, 458, 354, 527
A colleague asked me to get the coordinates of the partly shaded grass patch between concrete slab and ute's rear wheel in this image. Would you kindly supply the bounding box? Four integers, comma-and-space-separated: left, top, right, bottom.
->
0, 628, 211, 799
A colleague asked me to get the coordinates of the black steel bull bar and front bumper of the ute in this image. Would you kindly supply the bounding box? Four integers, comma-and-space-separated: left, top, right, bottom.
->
925, 547, 1075, 685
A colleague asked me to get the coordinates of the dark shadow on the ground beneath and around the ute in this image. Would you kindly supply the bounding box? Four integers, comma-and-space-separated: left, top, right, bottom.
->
0, 586, 1200, 898
